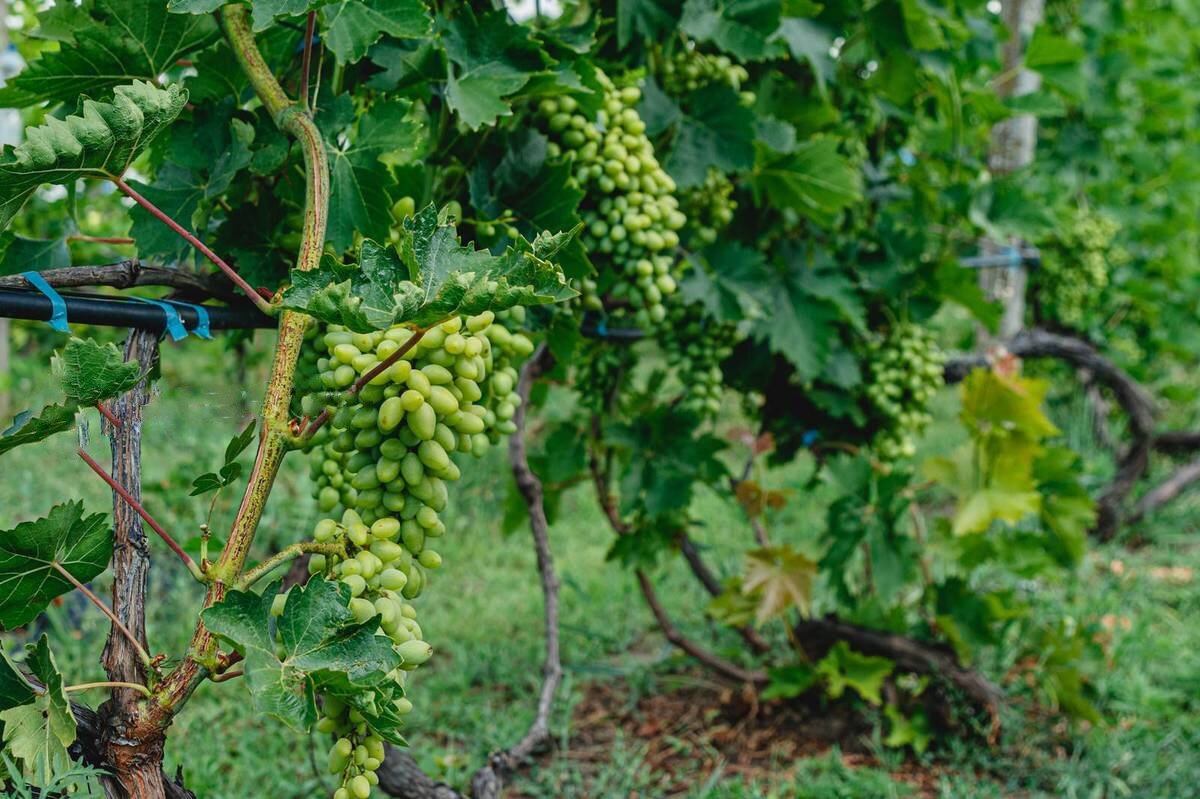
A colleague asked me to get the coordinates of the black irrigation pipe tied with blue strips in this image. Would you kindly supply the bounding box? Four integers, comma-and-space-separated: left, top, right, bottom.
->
0, 288, 277, 332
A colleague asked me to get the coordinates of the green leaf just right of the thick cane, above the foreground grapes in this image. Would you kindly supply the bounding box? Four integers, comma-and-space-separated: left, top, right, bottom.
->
323, 100, 424, 251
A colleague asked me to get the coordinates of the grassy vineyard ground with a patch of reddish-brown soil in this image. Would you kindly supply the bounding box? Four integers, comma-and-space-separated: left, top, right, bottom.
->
0, 343, 1200, 799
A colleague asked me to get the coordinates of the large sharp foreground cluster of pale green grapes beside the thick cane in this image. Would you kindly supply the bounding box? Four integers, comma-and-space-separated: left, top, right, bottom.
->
290, 310, 533, 799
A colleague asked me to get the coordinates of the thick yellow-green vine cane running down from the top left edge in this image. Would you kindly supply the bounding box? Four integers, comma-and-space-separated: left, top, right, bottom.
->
151, 4, 329, 728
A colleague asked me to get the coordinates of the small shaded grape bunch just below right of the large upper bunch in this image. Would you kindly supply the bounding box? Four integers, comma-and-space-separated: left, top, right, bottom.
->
658, 302, 737, 417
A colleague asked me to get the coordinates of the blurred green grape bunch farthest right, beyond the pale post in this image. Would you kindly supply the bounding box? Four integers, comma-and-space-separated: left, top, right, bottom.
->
1032, 211, 1122, 326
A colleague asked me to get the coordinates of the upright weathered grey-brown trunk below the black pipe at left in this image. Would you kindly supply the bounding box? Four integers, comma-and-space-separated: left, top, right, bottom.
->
98, 330, 175, 799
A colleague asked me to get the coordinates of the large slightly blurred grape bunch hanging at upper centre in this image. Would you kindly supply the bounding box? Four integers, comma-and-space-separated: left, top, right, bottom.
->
538, 73, 686, 328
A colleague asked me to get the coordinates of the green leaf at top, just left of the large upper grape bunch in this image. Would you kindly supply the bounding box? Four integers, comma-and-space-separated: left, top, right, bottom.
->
442, 6, 551, 130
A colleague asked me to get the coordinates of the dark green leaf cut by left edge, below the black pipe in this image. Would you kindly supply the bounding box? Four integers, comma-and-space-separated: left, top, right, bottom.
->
0, 501, 113, 630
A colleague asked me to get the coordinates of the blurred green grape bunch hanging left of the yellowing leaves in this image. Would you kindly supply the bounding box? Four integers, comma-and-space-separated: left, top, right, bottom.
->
866, 324, 946, 461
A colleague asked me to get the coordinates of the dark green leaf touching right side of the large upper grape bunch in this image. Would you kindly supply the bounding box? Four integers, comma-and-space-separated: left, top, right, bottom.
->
666, 84, 755, 188
